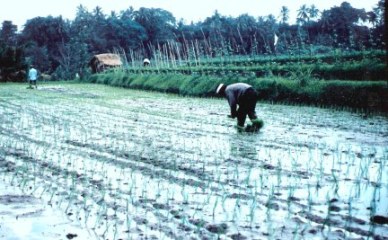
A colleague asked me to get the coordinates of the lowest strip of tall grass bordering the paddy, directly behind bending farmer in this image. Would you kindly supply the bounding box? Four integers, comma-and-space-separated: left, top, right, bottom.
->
85, 70, 388, 112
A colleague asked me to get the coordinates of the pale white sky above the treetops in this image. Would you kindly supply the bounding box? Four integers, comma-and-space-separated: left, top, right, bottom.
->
0, 0, 378, 30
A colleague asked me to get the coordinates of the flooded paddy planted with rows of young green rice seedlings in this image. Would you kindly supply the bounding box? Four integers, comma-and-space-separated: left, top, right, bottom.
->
0, 84, 388, 239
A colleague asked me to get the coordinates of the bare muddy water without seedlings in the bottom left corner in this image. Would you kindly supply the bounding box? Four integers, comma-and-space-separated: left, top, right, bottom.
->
0, 182, 90, 239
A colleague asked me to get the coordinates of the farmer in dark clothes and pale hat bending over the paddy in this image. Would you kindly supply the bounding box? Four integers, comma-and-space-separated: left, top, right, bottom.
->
216, 83, 263, 131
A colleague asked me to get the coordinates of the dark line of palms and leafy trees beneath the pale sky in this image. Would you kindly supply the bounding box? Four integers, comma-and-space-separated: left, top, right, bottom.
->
0, 0, 386, 81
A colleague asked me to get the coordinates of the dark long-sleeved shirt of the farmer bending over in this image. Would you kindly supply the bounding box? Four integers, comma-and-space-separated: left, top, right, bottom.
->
225, 83, 252, 117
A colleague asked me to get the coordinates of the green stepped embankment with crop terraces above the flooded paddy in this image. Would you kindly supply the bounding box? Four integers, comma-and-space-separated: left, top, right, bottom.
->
83, 51, 388, 112
